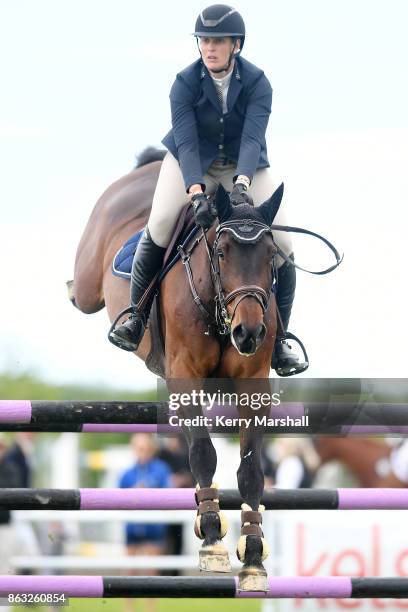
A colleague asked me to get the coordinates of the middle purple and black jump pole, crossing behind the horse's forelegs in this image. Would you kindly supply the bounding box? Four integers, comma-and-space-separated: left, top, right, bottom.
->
0, 488, 408, 510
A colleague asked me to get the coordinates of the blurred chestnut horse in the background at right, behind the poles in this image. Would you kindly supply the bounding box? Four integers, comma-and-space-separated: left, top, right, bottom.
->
317, 438, 390, 487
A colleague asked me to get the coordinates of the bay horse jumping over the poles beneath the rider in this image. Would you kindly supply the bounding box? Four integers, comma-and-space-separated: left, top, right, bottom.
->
72, 147, 283, 591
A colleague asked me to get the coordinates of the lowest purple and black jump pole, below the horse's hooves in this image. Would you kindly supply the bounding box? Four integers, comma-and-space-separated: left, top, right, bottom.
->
0, 576, 408, 599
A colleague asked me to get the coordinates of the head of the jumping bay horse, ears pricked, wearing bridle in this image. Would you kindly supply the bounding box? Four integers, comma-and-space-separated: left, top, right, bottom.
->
214, 183, 283, 356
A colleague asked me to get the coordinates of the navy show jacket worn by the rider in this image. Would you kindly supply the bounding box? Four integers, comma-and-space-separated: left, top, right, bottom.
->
162, 57, 272, 190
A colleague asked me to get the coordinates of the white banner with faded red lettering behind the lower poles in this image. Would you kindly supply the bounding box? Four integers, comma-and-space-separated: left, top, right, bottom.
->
262, 510, 408, 612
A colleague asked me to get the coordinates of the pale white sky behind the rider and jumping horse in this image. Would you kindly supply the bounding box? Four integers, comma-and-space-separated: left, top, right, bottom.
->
0, 0, 408, 389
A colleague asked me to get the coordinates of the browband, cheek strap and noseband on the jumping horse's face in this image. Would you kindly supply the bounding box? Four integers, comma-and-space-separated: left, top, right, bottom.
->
205, 219, 275, 335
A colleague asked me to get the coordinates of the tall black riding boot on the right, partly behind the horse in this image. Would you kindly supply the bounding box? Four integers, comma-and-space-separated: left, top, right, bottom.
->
272, 253, 309, 376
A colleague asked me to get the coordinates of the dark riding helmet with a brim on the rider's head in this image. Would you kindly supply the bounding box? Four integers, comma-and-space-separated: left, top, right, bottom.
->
193, 4, 245, 49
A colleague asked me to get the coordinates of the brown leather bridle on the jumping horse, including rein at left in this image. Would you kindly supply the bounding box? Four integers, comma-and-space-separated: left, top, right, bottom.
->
179, 219, 276, 336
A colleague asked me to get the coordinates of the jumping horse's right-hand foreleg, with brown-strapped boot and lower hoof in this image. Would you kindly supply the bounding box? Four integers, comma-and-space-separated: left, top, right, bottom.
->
237, 415, 269, 591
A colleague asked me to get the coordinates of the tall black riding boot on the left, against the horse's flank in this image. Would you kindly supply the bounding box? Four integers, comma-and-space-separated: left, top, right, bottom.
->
109, 228, 166, 351
